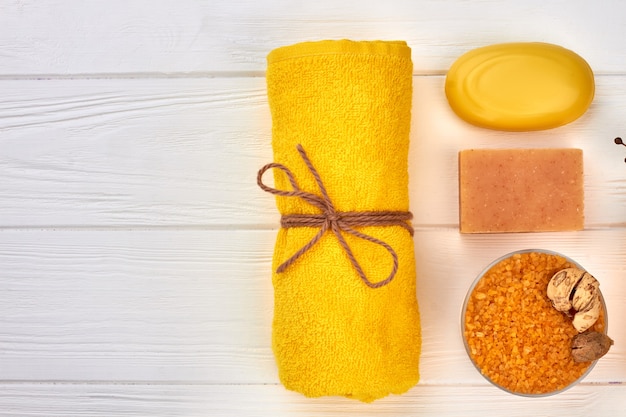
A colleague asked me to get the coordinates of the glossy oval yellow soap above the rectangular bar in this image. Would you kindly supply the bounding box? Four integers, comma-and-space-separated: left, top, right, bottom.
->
445, 42, 595, 131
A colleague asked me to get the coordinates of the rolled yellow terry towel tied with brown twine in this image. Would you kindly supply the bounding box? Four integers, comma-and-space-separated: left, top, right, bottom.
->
258, 40, 421, 402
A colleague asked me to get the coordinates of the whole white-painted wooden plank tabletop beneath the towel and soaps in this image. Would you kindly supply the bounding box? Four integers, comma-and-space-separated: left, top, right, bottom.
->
0, 0, 626, 417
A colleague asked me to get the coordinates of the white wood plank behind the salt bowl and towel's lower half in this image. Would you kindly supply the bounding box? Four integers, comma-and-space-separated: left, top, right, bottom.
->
0, 229, 626, 385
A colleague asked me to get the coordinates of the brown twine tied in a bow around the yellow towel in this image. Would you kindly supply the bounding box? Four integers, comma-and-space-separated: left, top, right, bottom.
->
257, 145, 413, 288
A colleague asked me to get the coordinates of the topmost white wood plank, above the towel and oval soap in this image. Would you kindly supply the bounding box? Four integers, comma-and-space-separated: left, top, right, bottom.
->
0, 0, 626, 77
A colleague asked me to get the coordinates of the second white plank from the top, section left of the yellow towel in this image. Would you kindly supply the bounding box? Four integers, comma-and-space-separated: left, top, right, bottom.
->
0, 78, 274, 227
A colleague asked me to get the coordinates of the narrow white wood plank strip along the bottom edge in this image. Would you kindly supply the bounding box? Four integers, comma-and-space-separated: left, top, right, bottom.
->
0, 383, 626, 417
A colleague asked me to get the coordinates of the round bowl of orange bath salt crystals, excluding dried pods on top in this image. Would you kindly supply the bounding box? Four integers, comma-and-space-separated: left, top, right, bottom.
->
461, 249, 612, 396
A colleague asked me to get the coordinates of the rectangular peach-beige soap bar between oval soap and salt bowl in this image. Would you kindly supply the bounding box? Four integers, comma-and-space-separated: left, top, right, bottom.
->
459, 149, 584, 233
